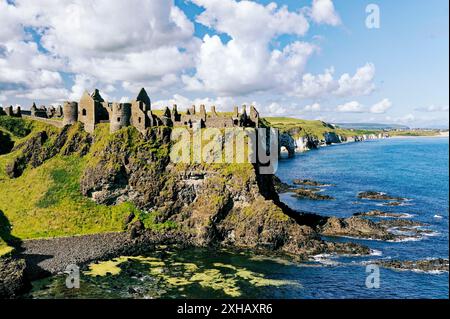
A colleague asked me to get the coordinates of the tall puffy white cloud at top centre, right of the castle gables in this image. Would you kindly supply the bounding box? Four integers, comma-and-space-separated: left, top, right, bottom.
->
183, 0, 316, 95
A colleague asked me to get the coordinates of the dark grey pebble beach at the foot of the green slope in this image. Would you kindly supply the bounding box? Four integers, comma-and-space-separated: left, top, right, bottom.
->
0, 230, 192, 298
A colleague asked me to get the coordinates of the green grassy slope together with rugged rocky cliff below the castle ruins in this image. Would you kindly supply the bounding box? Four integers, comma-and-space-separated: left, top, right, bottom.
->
0, 116, 369, 258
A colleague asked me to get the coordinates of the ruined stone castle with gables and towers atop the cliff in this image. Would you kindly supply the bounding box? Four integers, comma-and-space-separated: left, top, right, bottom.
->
0, 89, 259, 133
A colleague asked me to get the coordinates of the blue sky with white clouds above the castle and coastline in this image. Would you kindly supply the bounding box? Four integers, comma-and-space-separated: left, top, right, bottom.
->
0, 0, 449, 128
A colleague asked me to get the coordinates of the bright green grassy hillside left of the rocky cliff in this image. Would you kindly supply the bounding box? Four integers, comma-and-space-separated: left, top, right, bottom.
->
0, 116, 146, 255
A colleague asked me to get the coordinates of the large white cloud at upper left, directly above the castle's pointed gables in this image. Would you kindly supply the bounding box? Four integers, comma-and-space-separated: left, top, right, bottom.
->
8, 0, 200, 92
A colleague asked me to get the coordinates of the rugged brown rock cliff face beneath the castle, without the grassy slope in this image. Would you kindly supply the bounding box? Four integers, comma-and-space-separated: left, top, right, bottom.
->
77, 124, 366, 258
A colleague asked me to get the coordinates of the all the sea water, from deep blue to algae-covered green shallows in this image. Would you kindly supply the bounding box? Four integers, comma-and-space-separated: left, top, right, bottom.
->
29, 138, 449, 299
